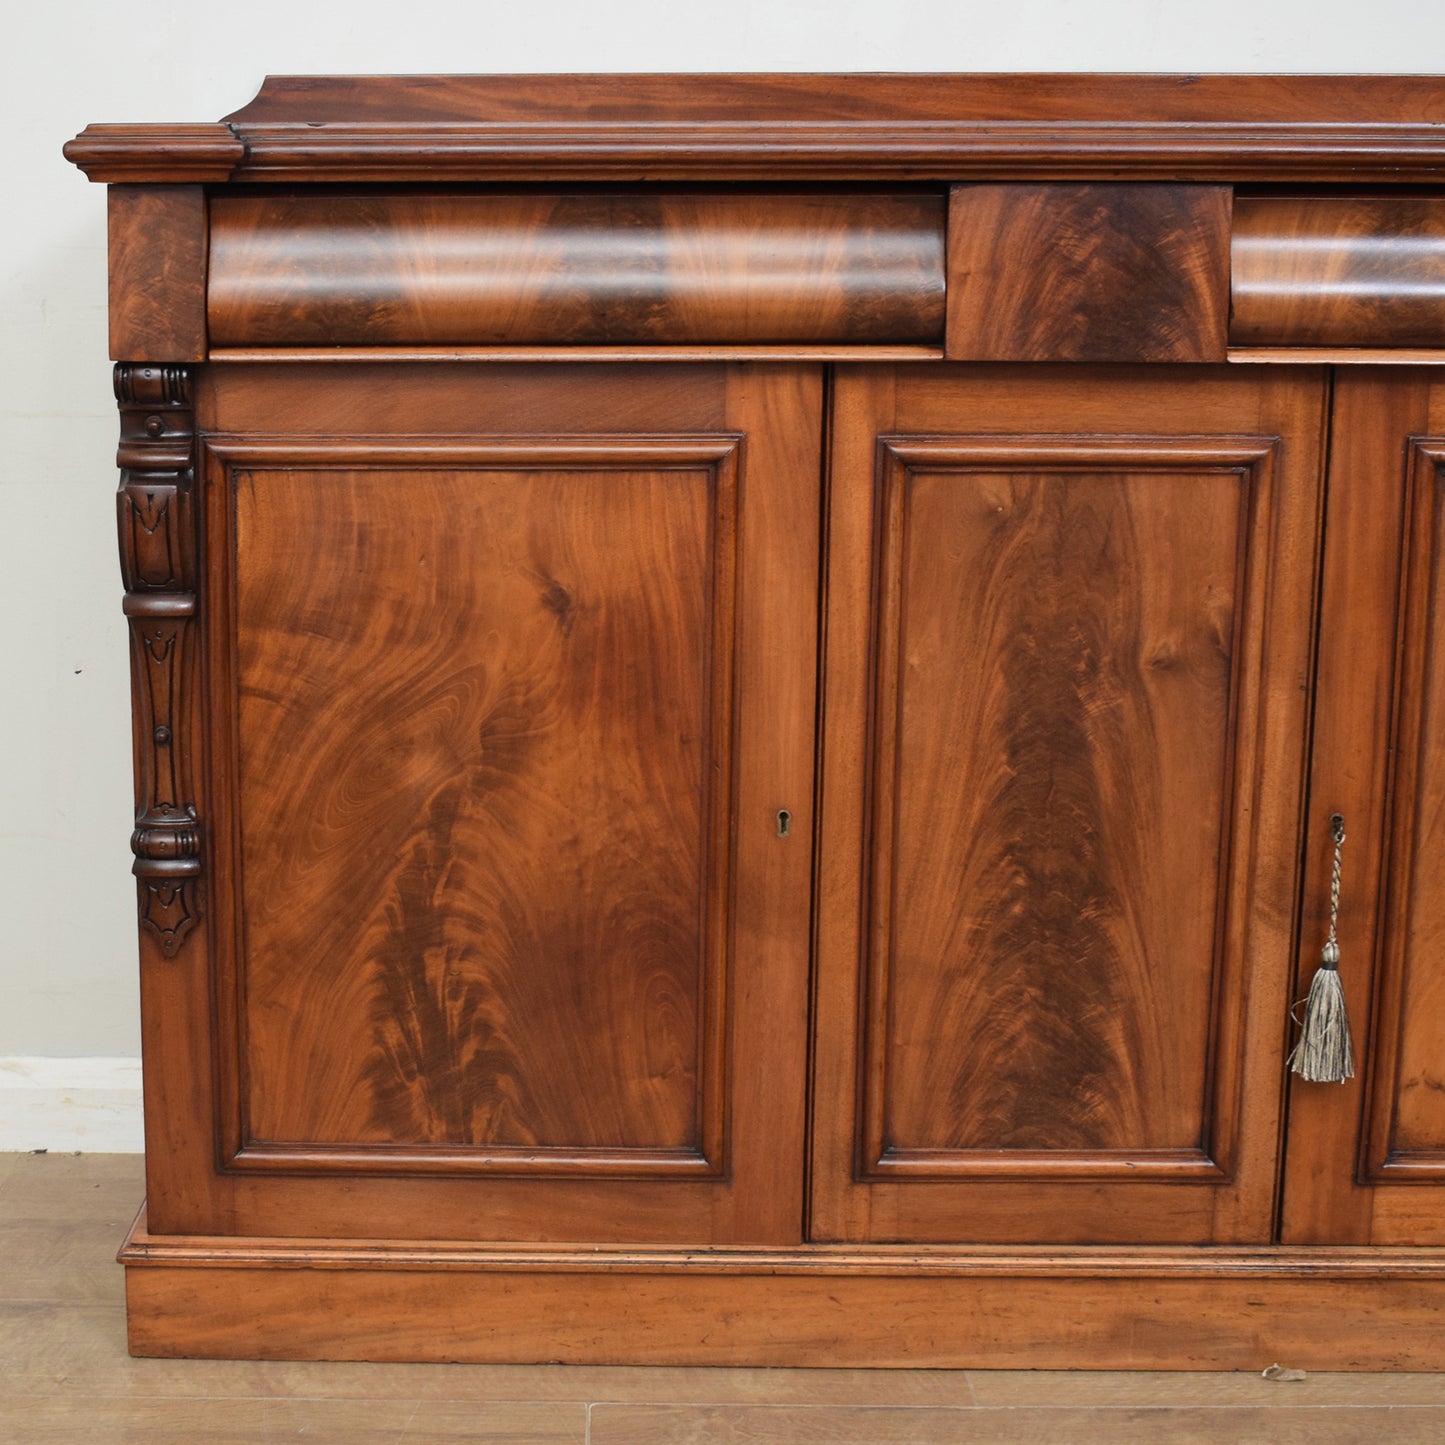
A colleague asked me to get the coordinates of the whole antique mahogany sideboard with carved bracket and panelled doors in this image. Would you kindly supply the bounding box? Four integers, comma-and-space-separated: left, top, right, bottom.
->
66, 75, 1445, 1370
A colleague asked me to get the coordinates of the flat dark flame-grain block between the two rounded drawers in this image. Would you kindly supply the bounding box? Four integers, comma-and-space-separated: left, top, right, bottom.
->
945, 185, 1230, 361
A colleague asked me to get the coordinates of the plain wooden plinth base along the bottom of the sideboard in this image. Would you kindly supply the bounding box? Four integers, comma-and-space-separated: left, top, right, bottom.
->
120, 1211, 1445, 1370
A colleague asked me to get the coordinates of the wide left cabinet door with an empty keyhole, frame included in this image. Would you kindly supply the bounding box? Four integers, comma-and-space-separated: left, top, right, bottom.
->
147, 364, 821, 1243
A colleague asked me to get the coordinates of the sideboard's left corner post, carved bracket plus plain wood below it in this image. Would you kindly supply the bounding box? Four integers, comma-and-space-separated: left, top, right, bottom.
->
114, 363, 225, 1228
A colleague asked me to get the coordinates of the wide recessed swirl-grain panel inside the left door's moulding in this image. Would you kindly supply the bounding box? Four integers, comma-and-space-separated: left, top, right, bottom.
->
231, 452, 731, 1159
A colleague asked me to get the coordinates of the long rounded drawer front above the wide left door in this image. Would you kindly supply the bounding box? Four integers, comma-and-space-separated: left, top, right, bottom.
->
210, 192, 944, 347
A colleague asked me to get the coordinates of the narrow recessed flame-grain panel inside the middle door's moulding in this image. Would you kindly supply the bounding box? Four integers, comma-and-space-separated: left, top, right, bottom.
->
874, 452, 1246, 1169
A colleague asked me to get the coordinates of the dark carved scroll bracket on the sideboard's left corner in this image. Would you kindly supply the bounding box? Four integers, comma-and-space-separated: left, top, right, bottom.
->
116, 363, 201, 957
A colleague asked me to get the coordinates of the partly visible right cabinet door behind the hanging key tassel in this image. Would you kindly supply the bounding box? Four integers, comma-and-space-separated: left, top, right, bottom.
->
1283, 367, 1445, 1246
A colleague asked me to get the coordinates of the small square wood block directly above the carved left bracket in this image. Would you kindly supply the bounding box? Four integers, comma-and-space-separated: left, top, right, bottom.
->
107, 185, 207, 361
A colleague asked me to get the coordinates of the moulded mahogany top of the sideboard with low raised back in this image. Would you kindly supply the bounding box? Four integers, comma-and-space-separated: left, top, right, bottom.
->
65, 74, 1445, 185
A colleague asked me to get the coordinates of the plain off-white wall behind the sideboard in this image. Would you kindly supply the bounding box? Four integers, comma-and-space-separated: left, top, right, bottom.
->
0, 0, 1445, 1149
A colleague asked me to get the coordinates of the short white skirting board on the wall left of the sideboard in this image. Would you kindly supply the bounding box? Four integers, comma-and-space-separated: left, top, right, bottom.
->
0, 1056, 143, 1155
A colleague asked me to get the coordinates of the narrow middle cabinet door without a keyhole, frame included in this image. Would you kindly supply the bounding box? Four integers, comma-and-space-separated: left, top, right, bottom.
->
811, 367, 1325, 1243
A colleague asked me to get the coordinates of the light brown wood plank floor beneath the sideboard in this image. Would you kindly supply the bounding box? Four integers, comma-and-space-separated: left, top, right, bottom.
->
0, 1155, 1445, 1445
